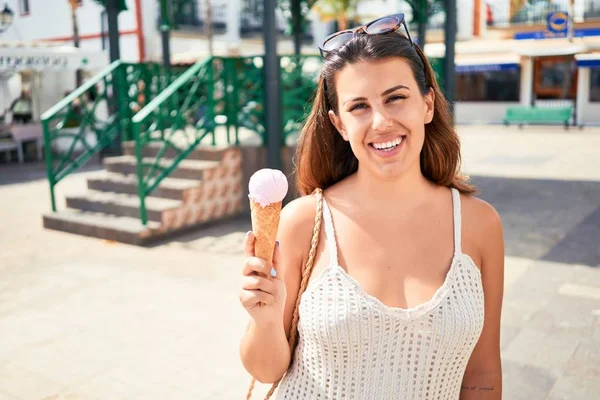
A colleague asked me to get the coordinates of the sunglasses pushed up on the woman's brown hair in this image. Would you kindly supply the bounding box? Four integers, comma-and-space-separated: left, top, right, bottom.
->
319, 13, 415, 58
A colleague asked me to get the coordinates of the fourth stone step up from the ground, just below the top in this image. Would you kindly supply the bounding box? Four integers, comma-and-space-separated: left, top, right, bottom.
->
104, 156, 220, 180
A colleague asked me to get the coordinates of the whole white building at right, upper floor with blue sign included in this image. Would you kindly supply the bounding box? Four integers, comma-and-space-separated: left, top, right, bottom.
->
425, 0, 600, 126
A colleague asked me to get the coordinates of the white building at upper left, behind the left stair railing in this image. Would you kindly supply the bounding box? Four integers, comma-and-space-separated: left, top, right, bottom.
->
0, 0, 144, 120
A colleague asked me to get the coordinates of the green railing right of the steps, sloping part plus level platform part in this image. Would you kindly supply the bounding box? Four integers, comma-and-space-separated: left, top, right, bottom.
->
132, 56, 321, 224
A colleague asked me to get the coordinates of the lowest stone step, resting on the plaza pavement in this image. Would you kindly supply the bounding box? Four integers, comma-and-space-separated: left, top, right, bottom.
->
43, 209, 160, 246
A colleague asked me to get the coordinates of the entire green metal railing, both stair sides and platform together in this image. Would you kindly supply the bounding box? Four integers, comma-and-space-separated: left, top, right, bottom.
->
42, 56, 321, 224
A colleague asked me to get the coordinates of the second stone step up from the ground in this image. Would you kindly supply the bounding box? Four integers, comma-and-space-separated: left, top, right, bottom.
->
66, 190, 183, 222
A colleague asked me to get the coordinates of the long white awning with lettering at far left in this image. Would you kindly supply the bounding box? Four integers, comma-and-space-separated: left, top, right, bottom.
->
0, 42, 109, 72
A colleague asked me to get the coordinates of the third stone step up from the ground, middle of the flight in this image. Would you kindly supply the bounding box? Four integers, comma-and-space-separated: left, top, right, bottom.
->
87, 172, 202, 201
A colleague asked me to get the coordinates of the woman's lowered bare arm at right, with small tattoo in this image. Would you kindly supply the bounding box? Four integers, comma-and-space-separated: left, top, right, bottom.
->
460, 199, 504, 400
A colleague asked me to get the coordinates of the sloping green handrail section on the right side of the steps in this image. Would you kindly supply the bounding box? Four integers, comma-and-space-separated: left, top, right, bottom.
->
132, 58, 215, 225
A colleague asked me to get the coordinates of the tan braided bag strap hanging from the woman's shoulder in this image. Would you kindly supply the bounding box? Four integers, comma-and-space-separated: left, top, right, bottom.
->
246, 188, 323, 400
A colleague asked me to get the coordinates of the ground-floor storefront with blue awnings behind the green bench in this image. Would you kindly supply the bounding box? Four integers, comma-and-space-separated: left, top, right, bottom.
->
427, 37, 600, 126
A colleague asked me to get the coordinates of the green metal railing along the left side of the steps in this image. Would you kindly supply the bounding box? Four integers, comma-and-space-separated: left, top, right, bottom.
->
41, 61, 179, 211
